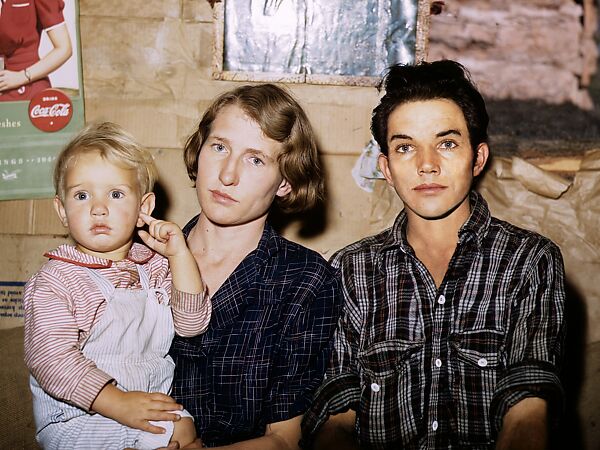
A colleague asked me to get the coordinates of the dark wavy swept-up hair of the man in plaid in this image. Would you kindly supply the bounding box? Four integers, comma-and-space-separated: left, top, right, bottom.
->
371, 60, 489, 155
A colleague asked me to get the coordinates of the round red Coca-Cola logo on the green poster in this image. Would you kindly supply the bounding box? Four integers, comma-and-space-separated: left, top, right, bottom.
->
29, 89, 73, 132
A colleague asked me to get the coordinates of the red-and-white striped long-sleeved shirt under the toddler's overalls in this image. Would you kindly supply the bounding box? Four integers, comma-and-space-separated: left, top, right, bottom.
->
23, 243, 211, 411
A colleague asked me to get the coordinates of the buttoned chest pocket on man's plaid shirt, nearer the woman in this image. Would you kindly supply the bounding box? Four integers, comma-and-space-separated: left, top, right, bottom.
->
358, 339, 423, 447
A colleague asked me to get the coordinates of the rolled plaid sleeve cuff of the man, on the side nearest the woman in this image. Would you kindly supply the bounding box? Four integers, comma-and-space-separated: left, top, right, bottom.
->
300, 373, 360, 449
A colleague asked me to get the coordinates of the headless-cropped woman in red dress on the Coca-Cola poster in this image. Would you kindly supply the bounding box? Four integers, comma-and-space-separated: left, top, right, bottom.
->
0, 0, 73, 101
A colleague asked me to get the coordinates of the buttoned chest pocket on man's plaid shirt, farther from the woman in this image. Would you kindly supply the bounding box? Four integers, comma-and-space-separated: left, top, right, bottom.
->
450, 330, 504, 446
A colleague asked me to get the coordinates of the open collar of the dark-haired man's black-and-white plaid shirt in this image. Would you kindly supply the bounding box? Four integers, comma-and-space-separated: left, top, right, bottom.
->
381, 191, 491, 253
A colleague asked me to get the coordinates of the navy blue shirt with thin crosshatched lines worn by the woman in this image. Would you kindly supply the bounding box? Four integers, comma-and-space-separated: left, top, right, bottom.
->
170, 217, 341, 447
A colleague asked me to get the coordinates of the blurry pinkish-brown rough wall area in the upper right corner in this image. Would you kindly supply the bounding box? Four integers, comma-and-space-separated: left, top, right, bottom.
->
428, 0, 598, 109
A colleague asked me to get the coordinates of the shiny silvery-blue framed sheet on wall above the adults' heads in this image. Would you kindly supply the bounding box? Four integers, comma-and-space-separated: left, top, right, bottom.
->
213, 0, 431, 86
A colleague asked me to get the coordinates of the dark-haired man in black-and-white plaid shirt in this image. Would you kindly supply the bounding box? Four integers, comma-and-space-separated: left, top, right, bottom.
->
303, 61, 565, 450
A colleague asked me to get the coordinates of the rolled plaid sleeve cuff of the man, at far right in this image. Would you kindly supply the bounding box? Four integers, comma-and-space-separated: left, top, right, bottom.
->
490, 361, 564, 436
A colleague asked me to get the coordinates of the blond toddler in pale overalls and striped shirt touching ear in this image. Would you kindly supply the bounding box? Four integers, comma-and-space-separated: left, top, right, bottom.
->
23, 123, 211, 450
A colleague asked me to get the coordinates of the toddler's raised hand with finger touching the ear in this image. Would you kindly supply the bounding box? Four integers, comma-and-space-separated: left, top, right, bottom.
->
138, 212, 188, 258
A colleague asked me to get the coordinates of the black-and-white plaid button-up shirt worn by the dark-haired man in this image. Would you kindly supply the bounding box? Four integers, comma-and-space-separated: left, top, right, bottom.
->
303, 192, 565, 450
